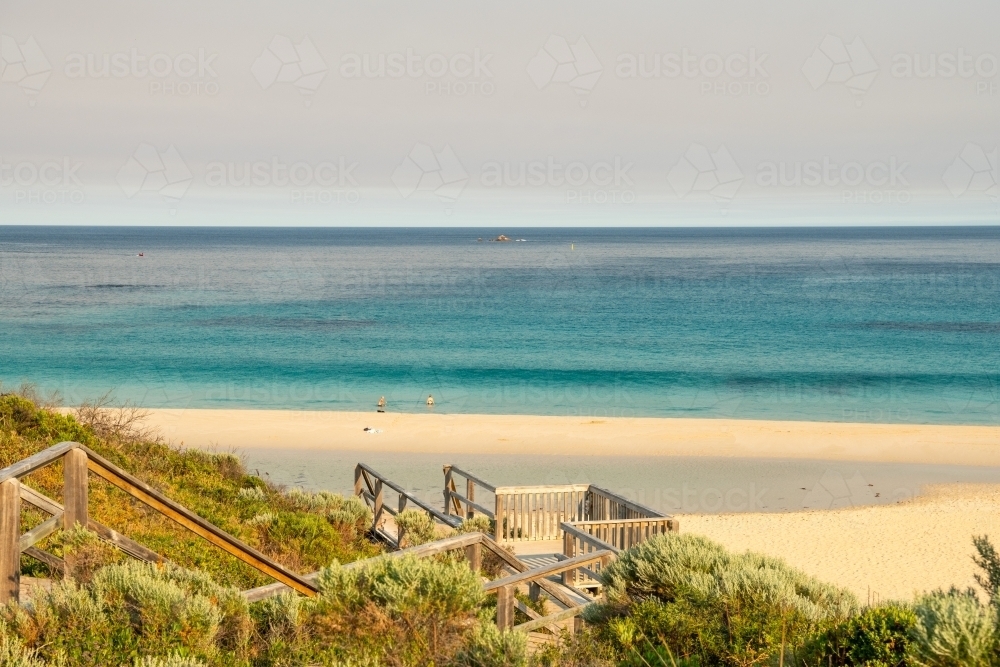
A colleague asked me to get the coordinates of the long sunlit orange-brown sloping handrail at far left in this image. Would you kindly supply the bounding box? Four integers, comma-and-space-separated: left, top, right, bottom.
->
80, 446, 316, 596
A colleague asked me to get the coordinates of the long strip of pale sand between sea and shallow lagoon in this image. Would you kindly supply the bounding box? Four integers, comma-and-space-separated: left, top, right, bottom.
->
141, 410, 1000, 466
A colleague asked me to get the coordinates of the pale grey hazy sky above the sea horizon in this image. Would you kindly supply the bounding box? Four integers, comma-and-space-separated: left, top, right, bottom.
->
0, 0, 1000, 227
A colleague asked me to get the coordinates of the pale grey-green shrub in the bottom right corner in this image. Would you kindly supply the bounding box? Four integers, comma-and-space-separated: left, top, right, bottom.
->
910, 588, 996, 667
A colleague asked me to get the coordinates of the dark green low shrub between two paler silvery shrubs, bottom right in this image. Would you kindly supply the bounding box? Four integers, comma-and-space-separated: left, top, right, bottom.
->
800, 603, 917, 667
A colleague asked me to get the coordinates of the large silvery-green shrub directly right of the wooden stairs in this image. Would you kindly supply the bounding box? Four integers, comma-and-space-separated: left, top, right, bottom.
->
586, 534, 857, 666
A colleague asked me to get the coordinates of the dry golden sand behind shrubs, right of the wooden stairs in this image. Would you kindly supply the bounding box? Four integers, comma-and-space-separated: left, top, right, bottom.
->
680, 484, 1000, 602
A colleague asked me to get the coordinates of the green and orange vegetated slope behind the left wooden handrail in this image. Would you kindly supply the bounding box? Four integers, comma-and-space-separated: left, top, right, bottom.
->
0, 394, 378, 588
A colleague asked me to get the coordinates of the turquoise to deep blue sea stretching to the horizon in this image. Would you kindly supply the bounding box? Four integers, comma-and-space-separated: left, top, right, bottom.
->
0, 227, 1000, 424
